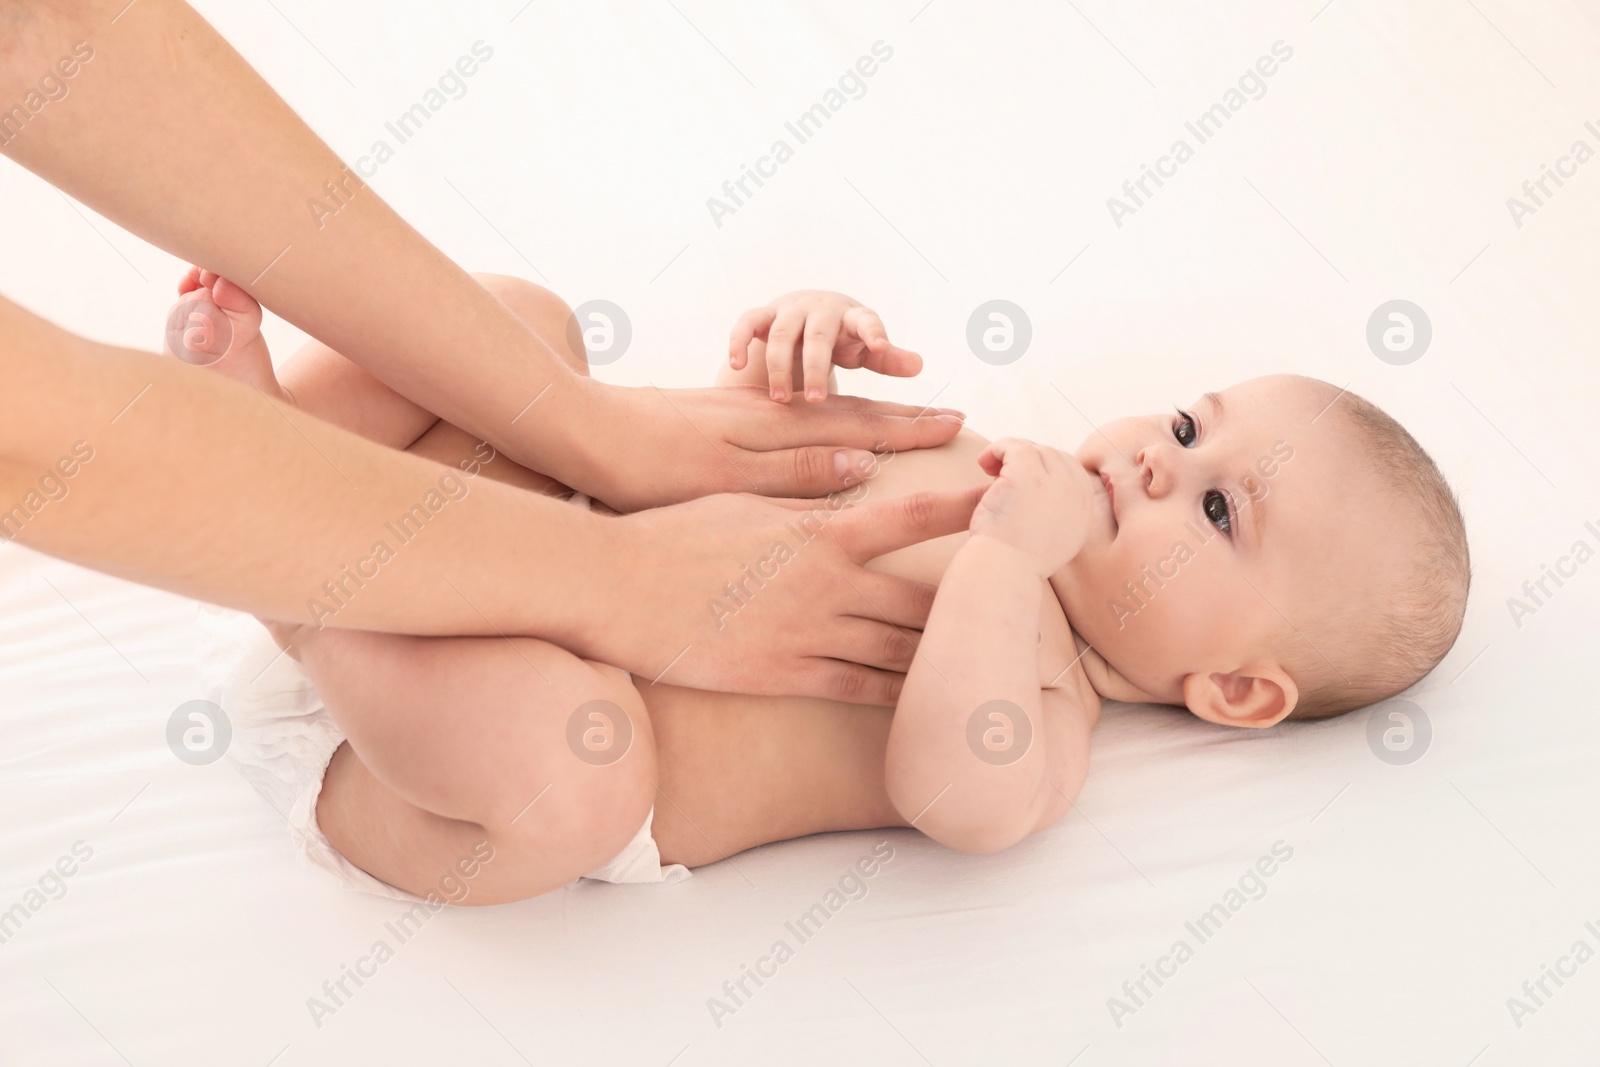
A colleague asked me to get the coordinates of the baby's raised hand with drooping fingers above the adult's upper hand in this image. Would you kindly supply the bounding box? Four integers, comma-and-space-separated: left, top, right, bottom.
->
728, 290, 922, 403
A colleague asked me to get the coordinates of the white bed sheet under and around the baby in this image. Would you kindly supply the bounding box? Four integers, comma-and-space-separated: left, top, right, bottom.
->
0, 0, 1600, 1067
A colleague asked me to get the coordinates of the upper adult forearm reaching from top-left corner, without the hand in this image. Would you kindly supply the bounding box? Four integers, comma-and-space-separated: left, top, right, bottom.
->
0, 0, 598, 485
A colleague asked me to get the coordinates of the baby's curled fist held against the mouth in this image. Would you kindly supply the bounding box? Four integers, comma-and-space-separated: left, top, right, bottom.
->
971, 437, 1094, 577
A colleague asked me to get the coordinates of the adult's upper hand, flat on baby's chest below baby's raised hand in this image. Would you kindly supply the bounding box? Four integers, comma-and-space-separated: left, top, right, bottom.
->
568, 379, 962, 512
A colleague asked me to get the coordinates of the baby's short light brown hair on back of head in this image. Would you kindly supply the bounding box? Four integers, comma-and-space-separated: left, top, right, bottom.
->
1285, 392, 1472, 718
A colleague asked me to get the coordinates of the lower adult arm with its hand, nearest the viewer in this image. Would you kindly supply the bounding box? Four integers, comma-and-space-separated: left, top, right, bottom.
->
0, 299, 978, 704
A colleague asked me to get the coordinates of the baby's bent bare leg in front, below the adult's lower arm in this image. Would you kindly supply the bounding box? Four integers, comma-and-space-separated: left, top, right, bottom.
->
278, 625, 656, 904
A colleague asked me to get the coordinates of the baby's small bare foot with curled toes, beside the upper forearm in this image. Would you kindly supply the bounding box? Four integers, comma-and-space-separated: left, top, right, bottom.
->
166, 267, 293, 402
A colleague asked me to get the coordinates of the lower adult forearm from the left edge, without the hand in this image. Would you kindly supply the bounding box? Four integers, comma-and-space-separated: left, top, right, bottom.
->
0, 301, 616, 643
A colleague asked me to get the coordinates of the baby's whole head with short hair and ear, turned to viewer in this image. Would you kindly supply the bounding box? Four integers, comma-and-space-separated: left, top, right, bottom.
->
1051, 374, 1469, 726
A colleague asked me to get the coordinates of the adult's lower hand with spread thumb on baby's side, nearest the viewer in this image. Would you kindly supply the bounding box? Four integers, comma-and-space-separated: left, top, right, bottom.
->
588, 483, 984, 705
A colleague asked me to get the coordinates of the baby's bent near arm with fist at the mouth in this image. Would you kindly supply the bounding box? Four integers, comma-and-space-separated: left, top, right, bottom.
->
885, 440, 1099, 853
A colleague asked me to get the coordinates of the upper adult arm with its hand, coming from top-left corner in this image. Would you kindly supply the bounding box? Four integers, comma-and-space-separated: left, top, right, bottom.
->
0, 0, 960, 510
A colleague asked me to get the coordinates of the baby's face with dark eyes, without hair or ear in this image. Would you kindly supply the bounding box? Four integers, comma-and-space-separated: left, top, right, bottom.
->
1051, 376, 1392, 704
